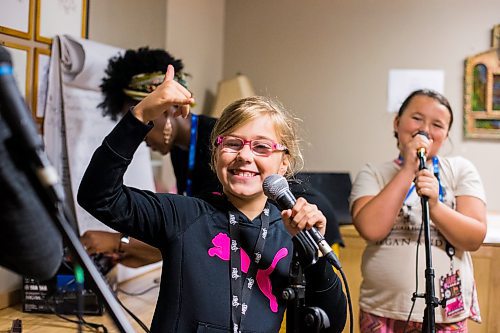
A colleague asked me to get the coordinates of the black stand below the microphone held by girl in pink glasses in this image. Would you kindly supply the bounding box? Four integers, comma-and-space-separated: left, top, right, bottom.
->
282, 233, 330, 333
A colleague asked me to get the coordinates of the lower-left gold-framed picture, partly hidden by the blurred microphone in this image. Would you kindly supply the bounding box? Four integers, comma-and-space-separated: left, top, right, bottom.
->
0, 42, 31, 99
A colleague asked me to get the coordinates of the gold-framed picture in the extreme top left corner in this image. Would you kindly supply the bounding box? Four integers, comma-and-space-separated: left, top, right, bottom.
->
0, 0, 35, 39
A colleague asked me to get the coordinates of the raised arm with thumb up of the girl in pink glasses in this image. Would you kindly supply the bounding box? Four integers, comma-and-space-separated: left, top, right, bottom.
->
77, 66, 193, 243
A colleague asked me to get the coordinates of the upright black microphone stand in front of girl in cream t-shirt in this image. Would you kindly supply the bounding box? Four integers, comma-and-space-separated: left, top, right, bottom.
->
418, 150, 439, 333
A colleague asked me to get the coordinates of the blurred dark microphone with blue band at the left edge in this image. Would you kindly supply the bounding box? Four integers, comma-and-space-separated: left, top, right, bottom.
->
0, 46, 64, 204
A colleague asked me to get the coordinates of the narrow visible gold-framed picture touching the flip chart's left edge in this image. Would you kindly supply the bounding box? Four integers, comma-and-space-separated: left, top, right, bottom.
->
32, 47, 50, 120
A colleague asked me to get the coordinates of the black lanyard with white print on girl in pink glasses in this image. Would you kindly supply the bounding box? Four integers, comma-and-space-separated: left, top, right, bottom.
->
229, 203, 269, 333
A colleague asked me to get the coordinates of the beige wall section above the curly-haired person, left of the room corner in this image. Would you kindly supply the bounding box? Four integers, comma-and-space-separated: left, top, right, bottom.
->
89, 0, 225, 113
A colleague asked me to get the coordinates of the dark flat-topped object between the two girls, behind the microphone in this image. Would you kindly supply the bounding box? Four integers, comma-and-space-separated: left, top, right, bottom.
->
296, 172, 352, 224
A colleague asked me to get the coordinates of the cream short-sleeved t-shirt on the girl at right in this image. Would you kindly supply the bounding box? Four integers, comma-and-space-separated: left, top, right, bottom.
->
349, 157, 486, 323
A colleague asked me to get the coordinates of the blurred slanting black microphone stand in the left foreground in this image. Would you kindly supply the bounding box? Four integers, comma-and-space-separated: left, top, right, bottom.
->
0, 98, 134, 333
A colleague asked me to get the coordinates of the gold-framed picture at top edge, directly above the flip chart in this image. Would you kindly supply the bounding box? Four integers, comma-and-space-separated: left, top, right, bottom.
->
35, 0, 87, 44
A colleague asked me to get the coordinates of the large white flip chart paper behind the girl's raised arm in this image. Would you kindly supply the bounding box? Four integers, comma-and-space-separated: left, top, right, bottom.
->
44, 35, 157, 281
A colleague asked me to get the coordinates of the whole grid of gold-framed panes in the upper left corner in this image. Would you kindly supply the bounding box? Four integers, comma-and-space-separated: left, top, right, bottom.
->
0, 0, 88, 131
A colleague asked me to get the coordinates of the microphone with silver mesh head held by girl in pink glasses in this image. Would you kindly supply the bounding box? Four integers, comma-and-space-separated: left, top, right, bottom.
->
262, 174, 342, 270
